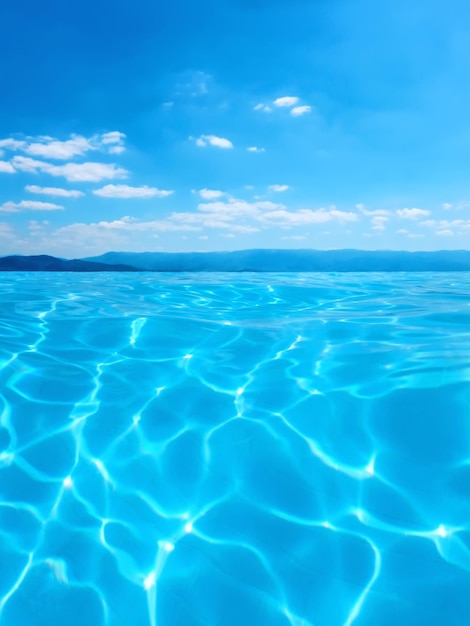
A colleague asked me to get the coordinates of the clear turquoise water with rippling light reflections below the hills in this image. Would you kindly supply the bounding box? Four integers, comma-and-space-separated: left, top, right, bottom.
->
0, 273, 470, 626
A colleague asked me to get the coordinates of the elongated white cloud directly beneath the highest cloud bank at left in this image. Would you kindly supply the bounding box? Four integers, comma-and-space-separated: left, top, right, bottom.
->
11, 156, 127, 183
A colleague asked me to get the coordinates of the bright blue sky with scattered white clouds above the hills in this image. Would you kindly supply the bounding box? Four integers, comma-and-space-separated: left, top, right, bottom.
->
0, 0, 470, 258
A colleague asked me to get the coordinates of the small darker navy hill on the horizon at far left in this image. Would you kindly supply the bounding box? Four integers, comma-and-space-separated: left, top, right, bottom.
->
0, 254, 140, 272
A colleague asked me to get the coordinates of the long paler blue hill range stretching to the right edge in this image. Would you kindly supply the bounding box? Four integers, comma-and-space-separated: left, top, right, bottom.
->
81, 250, 470, 272
